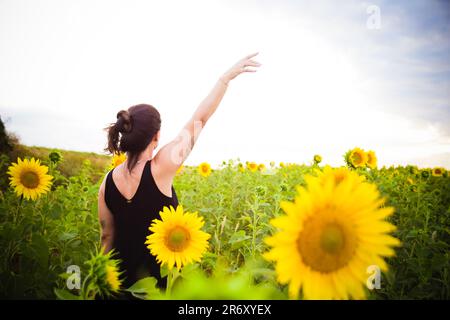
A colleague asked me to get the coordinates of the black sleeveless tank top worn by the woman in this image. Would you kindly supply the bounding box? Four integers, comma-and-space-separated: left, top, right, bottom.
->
105, 160, 178, 288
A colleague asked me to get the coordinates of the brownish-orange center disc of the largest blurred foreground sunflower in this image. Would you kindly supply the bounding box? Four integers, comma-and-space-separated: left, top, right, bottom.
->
297, 216, 356, 273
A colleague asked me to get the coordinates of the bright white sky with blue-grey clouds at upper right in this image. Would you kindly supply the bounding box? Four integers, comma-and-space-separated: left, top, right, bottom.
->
0, 0, 450, 168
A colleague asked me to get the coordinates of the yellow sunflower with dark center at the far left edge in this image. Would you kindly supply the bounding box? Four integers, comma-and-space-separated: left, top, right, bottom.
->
8, 158, 53, 200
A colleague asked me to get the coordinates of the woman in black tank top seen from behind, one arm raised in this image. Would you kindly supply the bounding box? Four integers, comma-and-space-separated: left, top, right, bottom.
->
98, 53, 260, 288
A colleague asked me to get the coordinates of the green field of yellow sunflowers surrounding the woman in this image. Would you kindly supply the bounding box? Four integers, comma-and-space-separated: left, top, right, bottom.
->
0, 148, 450, 299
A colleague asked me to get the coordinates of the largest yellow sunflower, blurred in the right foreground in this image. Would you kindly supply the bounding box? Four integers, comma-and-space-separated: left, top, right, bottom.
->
264, 168, 400, 299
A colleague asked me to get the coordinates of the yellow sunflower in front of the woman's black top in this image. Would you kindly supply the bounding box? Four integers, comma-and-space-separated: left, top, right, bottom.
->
145, 205, 210, 270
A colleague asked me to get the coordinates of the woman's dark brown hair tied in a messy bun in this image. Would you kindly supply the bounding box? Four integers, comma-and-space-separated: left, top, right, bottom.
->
105, 104, 161, 172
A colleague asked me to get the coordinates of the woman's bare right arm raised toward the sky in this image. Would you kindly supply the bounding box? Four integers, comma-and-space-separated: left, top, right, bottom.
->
153, 53, 261, 178
